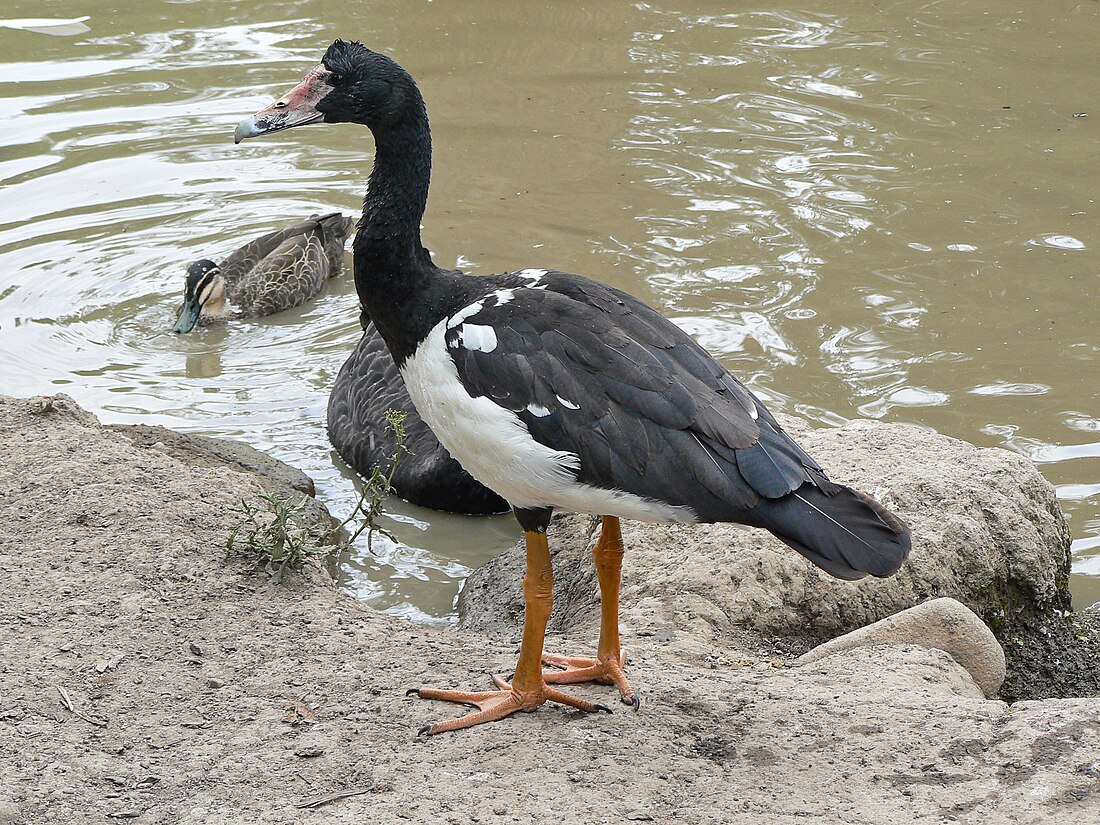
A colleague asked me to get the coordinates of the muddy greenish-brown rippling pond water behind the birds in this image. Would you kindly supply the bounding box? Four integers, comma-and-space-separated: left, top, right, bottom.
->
0, 0, 1100, 620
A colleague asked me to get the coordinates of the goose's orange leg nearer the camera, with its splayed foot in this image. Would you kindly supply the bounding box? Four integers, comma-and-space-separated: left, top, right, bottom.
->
406, 532, 611, 736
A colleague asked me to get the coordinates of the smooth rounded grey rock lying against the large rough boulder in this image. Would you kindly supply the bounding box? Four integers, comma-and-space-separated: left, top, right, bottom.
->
798, 597, 1004, 699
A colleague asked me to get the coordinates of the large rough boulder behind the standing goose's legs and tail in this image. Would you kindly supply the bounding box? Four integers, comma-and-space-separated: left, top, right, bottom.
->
459, 421, 1097, 697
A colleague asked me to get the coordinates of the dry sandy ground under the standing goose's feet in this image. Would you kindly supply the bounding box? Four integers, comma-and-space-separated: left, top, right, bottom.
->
0, 397, 1100, 825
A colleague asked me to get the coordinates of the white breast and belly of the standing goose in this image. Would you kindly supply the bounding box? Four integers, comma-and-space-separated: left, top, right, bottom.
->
400, 318, 695, 521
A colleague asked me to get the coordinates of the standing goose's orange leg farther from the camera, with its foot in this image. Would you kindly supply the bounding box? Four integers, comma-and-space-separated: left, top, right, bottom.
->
542, 516, 641, 711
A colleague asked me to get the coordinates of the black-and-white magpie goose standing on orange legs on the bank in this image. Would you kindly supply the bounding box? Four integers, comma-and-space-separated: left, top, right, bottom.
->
234, 41, 910, 735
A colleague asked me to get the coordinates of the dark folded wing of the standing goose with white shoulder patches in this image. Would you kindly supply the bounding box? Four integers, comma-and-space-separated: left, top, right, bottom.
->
446, 273, 824, 521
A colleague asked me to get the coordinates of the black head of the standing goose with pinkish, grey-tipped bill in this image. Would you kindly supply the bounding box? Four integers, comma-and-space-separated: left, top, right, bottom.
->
233, 40, 424, 143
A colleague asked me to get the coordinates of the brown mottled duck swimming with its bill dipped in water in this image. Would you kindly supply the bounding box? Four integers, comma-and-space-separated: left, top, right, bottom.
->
172, 212, 354, 332
